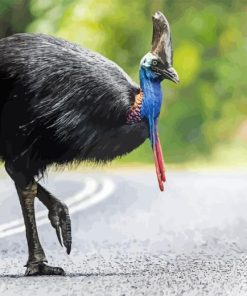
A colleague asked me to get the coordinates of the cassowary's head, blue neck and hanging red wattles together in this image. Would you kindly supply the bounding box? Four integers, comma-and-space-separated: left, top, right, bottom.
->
129, 12, 179, 191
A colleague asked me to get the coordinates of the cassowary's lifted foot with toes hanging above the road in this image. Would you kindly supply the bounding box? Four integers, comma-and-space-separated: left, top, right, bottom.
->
48, 200, 72, 254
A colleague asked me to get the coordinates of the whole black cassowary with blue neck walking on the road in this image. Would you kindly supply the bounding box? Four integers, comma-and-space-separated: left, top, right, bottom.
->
0, 12, 179, 275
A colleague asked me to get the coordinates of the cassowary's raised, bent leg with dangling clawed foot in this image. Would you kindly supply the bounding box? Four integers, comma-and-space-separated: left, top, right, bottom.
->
37, 183, 72, 254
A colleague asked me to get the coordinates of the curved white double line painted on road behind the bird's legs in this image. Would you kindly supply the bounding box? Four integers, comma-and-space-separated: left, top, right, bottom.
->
0, 178, 115, 238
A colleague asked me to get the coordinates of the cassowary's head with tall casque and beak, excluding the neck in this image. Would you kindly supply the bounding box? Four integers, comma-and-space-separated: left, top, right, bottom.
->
140, 12, 179, 83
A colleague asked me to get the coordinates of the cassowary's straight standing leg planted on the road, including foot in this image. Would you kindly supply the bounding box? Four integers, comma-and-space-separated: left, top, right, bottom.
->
5, 164, 65, 276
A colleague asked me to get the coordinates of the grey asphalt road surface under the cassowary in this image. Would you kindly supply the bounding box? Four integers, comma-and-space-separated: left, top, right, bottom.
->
0, 170, 247, 296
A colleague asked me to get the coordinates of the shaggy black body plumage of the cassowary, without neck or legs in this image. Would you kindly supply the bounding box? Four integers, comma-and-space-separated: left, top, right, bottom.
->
0, 34, 148, 176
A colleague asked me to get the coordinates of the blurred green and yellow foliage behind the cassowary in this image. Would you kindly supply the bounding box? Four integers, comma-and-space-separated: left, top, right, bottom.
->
0, 0, 247, 167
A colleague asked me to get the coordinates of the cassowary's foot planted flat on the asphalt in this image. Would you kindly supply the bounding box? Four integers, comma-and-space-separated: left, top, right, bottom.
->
25, 262, 65, 276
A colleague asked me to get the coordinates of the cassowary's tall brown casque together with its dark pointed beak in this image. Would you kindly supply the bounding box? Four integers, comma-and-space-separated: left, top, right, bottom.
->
151, 11, 179, 83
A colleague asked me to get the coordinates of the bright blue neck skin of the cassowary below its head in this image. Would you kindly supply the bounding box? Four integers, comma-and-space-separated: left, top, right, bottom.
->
140, 67, 162, 143
